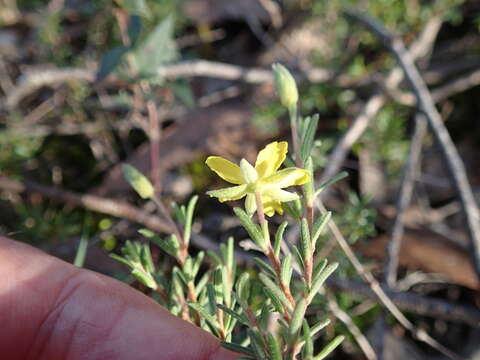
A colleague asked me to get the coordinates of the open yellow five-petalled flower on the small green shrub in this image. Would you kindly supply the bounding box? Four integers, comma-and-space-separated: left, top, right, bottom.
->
206, 141, 310, 216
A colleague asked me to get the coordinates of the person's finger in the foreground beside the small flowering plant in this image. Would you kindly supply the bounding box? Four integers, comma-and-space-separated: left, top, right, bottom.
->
0, 237, 238, 360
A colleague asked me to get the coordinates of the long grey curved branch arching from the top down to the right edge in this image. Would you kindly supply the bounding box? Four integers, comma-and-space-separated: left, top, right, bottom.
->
347, 12, 480, 284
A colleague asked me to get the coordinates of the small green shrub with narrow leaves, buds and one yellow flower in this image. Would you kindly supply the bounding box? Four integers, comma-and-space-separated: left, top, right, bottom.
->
112, 64, 344, 360
